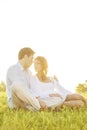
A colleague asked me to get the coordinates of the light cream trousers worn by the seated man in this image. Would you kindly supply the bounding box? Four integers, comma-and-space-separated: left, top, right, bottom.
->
11, 83, 40, 111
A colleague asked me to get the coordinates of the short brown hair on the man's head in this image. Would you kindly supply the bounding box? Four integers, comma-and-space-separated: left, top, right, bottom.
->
18, 47, 35, 60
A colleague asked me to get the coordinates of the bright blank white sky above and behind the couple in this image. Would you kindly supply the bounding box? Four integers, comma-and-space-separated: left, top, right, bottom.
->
0, 0, 87, 91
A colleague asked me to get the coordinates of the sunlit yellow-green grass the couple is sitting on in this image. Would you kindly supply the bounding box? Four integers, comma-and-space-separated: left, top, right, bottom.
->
0, 92, 87, 130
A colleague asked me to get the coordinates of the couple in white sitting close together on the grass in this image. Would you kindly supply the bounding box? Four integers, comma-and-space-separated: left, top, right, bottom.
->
6, 47, 85, 111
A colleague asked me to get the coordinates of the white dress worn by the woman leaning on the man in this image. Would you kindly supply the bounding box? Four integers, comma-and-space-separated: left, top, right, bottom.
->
30, 76, 66, 107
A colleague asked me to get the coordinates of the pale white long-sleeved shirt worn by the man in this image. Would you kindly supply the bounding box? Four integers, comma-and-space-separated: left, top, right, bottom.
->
6, 62, 32, 108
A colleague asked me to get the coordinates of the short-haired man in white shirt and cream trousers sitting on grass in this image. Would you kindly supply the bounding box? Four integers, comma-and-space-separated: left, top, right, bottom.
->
6, 47, 40, 111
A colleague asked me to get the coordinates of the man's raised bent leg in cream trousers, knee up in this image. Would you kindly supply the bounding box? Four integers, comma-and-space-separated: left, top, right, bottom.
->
12, 83, 40, 110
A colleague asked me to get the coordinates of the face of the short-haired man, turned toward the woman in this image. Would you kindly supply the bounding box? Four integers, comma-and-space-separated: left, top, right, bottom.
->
23, 55, 34, 69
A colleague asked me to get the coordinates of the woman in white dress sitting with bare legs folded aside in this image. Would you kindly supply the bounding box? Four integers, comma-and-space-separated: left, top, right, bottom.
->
30, 56, 85, 108
